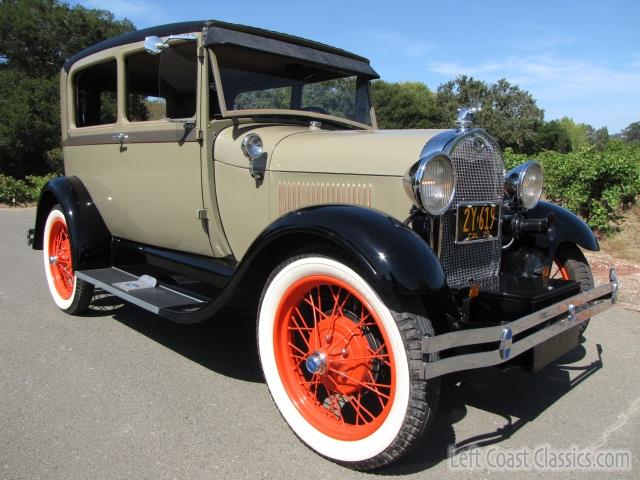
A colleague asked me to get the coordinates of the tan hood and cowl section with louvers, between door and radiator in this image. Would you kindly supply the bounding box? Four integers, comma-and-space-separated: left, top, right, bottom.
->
214, 124, 430, 259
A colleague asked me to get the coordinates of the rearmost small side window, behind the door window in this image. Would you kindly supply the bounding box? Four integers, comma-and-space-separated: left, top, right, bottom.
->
74, 60, 118, 127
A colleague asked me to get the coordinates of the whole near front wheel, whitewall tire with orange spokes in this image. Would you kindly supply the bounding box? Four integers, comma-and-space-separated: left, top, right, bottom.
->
258, 254, 439, 470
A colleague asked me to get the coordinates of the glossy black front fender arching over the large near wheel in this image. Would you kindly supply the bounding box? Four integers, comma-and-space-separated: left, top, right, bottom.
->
243, 205, 446, 294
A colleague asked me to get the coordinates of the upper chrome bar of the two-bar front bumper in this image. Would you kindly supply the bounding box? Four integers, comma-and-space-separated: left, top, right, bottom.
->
422, 283, 613, 353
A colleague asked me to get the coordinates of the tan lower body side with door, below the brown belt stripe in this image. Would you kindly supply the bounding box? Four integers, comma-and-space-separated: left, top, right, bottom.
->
64, 142, 212, 255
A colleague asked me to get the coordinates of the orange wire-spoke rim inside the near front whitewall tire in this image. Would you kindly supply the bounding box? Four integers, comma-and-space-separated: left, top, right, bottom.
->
274, 275, 396, 440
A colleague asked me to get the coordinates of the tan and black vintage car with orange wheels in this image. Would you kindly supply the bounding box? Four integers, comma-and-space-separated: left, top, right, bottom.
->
28, 21, 617, 470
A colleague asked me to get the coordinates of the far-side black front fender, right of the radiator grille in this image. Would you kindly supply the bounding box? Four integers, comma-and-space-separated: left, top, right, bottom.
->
527, 201, 600, 258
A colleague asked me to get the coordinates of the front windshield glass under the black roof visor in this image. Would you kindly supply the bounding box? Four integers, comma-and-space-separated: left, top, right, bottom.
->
214, 45, 371, 125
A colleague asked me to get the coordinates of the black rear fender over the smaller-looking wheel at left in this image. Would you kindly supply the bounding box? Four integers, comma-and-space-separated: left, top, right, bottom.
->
33, 177, 111, 270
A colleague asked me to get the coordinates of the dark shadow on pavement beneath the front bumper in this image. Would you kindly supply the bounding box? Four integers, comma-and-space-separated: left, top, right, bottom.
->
376, 339, 603, 475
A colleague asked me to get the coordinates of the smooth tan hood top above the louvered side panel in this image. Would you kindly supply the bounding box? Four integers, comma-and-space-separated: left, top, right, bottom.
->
269, 129, 446, 177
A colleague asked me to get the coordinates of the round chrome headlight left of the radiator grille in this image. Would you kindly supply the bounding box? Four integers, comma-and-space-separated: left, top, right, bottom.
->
404, 152, 456, 215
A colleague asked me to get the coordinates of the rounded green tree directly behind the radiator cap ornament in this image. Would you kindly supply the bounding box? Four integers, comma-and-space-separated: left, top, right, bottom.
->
436, 75, 544, 153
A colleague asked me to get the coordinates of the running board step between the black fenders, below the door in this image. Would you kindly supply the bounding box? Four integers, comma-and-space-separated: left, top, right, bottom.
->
76, 267, 208, 315
